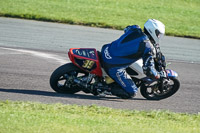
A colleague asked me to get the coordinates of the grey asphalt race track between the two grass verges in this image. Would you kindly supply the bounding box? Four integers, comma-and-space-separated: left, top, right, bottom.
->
0, 17, 200, 113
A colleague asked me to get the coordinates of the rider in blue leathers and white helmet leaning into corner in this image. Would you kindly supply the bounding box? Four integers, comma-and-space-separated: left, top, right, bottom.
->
101, 19, 165, 98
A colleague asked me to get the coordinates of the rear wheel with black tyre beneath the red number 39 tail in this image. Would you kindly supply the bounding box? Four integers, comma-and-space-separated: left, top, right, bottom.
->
50, 63, 87, 94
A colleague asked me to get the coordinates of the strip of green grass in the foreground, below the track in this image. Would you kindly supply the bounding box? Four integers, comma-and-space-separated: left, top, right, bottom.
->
0, 101, 200, 133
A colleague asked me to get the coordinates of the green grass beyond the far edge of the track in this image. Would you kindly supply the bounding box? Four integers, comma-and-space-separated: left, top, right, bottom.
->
0, 0, 200, 38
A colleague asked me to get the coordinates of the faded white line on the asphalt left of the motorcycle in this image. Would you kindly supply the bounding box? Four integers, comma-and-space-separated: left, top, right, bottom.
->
0, 47, 68, 64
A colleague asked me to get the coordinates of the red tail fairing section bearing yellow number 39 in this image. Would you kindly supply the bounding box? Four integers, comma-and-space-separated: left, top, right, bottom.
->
68, 48, 102, 77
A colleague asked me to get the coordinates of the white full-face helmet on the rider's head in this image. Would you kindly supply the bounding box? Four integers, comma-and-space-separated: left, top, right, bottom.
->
144, 19, 165, 44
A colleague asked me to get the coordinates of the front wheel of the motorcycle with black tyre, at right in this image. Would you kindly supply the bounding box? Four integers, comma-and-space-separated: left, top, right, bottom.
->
140, 78, 180, 100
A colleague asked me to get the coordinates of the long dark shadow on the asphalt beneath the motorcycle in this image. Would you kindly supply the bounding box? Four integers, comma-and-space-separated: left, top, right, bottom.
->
0, 88, 146, 102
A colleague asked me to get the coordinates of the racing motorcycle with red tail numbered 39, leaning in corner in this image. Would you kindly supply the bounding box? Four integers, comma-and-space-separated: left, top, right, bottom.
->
50, 48, 180, 100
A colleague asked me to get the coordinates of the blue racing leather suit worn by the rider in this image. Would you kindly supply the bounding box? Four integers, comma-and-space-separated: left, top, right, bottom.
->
101, 25, 158, 94
